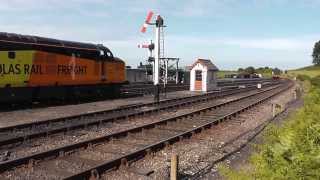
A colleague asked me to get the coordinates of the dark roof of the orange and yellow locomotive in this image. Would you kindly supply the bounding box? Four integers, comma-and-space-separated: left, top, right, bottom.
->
0, 32, 113, 59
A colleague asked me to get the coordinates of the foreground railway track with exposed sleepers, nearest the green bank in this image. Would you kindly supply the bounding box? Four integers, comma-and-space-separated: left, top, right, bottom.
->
0, 80, 288, 179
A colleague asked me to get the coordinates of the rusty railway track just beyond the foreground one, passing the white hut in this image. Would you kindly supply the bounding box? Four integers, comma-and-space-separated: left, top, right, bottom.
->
0, 82, 276, 149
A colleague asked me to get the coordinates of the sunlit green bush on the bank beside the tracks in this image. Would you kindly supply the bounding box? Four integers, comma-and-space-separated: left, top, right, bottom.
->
221, 77, 320, 179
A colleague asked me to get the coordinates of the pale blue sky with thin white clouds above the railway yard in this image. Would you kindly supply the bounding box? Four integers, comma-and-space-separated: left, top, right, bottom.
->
0, 0, 320, 70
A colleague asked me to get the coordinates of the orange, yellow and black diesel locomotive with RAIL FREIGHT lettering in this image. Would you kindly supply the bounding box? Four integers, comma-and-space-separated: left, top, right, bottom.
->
0, 33, 125, 104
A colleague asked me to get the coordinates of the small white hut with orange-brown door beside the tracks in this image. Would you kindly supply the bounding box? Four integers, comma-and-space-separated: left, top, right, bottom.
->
190, 59, 219, 92
